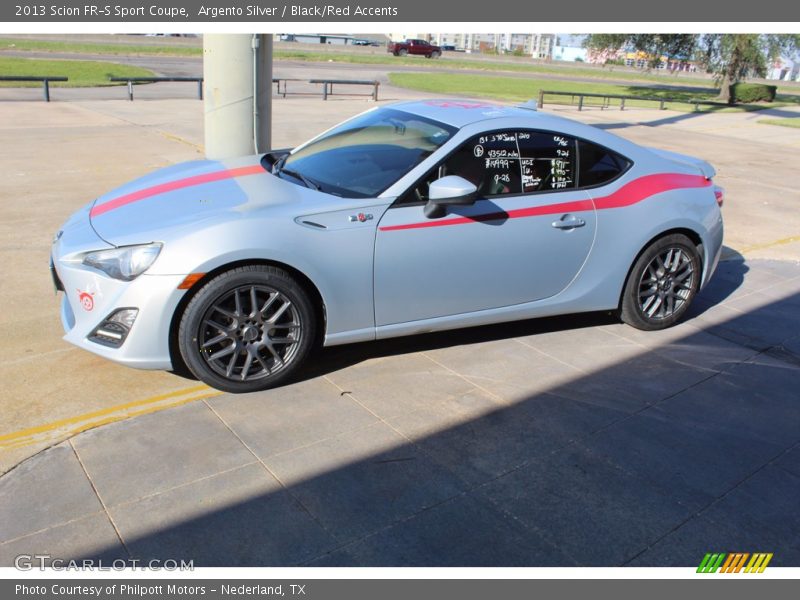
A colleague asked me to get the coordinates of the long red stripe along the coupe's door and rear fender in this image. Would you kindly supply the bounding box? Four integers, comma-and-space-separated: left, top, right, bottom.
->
380, 173, 711, 231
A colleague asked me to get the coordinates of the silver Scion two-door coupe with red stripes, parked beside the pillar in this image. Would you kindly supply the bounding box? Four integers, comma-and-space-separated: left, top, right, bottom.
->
52, 100, 723, 392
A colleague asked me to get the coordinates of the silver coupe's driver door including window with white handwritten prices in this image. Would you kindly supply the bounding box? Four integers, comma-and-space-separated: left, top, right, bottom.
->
374, 130, 596, 327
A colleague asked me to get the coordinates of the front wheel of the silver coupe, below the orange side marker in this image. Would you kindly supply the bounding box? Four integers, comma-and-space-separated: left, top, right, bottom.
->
178, 265, 317, 393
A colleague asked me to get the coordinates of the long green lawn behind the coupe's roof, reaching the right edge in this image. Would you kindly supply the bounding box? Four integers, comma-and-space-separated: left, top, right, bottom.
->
389, 73, 800, 112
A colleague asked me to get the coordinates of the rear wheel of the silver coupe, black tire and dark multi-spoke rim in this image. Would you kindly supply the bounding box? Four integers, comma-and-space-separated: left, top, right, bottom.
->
619, 234, 702, 331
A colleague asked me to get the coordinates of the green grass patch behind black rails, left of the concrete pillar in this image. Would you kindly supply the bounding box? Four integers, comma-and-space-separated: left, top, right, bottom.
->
0, 56, 154, 87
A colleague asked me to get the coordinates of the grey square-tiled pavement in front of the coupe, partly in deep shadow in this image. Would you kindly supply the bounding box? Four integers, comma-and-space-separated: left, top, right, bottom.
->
0, 260, 800, 566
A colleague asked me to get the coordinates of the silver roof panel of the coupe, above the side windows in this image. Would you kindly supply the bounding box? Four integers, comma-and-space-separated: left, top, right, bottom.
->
391, 98, 565, 129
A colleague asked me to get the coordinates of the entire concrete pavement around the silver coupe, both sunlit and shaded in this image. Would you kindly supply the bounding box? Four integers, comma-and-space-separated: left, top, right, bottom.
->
0, 81, 800, 566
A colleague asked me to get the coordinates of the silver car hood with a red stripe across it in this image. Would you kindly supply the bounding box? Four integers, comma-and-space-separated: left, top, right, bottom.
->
89, 156, 302, 245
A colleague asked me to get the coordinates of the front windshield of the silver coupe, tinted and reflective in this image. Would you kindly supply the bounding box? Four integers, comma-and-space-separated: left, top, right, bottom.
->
280, 108, 455, 198
